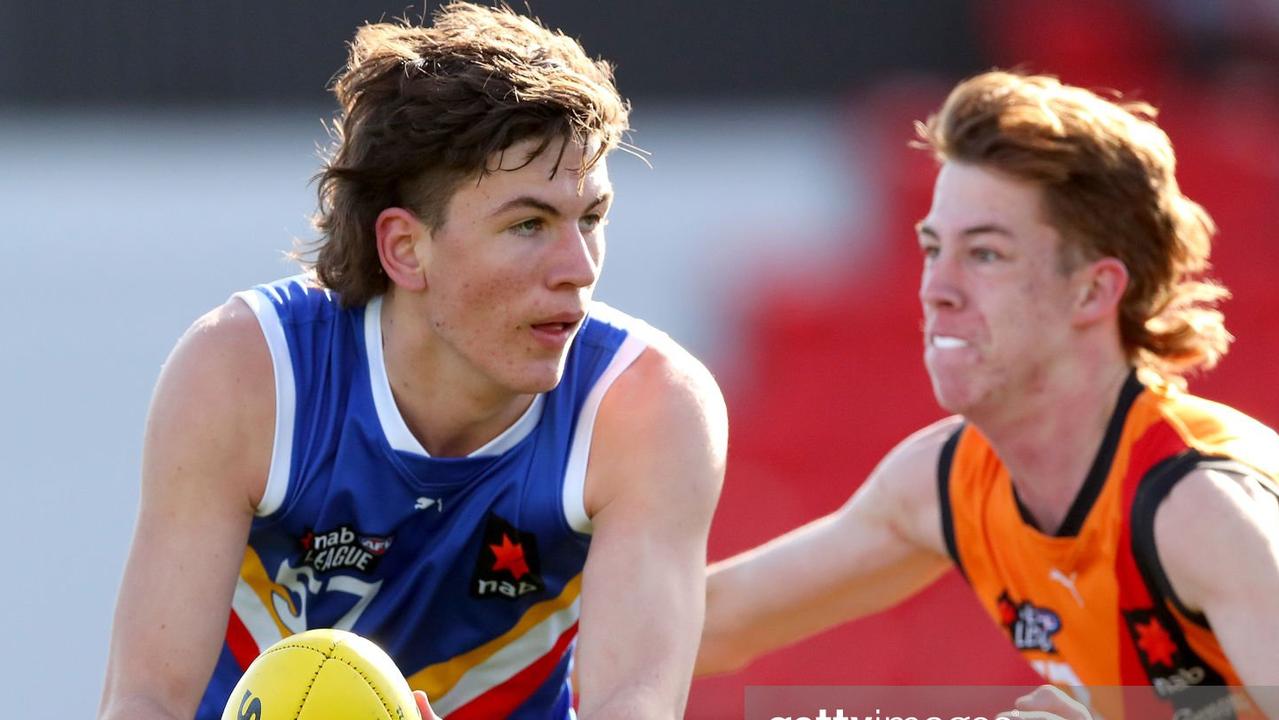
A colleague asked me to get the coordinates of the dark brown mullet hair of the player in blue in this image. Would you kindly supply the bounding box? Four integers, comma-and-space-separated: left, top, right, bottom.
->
305, 3, 629, 307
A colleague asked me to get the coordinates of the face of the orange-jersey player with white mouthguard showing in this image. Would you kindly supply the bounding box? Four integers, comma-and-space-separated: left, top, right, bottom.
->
917, 162, 1074, 417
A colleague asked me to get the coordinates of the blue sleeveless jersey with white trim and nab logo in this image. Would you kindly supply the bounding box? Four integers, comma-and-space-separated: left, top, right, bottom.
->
197, 276, 652, 720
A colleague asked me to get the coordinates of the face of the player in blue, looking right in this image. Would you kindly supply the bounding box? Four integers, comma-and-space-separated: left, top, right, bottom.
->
416, 139, 613, 394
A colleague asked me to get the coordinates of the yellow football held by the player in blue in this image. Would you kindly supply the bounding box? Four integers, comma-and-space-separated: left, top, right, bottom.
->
223, 629, 418, 720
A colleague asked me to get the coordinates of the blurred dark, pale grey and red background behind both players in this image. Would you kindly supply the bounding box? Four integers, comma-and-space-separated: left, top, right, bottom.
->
0, 0, 1279, 719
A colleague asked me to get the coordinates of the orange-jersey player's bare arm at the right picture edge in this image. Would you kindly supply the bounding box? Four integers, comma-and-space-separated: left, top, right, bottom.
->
1155, 469, 1279, 717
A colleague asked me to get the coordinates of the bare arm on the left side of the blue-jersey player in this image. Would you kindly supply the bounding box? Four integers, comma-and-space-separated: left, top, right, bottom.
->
100, 301, 275, 720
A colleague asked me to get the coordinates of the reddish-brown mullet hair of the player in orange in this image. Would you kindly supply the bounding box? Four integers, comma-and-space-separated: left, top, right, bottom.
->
914, 70, 1232, 387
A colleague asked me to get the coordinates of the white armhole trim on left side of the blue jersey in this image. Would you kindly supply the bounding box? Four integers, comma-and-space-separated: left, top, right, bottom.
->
233, 286, 297, 517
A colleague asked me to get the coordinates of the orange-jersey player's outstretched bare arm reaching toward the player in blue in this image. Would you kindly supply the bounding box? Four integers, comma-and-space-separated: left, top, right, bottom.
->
697, 419, 957, 675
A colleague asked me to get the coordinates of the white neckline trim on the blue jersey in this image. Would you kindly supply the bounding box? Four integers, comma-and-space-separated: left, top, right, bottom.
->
365, 295, 545, 458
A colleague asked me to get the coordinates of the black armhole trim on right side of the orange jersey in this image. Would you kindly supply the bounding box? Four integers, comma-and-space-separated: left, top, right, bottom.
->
1129, 449, 1279, 629
